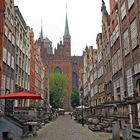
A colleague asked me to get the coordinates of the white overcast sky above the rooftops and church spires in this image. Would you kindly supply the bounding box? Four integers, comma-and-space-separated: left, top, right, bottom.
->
15, 0, 109, 55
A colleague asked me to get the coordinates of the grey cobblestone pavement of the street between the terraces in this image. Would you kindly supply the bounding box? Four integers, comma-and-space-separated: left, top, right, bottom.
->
26, 116, 111, 140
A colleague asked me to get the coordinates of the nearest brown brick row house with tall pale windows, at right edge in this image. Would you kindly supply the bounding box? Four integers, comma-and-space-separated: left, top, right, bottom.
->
116, 0, 140, 126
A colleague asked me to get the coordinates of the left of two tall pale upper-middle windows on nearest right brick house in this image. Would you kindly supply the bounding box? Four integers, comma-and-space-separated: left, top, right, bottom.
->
123, 29, 130, 56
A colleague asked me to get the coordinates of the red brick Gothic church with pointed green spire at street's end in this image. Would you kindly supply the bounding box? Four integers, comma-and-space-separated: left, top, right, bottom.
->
39, 11, 83, 110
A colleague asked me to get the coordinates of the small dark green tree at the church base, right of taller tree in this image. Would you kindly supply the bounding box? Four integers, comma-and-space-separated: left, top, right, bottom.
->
71, 89, 80, 108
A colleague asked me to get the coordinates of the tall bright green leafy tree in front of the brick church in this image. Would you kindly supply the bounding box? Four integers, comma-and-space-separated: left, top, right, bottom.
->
49, 72, 68, 108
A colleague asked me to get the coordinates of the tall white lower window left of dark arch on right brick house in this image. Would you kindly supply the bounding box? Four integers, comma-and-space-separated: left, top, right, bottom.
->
126, 68, 133, 96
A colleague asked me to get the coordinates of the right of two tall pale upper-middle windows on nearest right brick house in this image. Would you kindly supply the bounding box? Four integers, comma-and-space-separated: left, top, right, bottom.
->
130, 19, 138, 49
